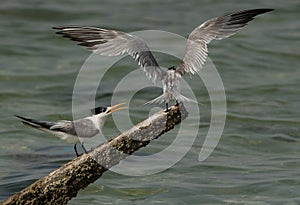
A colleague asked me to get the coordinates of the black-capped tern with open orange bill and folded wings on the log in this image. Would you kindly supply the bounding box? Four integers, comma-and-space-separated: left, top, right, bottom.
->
16, 103, 125, 156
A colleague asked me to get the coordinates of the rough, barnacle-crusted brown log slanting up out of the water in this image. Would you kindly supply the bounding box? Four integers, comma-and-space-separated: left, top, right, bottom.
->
1, 104, 188, 204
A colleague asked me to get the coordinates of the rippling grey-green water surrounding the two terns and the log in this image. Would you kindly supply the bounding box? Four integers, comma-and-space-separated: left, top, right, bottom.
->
0, 0, 300, 205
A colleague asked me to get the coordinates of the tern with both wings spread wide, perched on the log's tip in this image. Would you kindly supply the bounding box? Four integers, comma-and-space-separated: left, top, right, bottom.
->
53, 9, 273, 110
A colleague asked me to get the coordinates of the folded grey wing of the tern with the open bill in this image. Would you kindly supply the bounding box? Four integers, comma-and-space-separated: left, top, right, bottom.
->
50, 119, 99, 137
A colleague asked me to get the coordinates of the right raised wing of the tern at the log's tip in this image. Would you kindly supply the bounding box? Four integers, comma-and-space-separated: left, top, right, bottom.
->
177, 9, 273, 74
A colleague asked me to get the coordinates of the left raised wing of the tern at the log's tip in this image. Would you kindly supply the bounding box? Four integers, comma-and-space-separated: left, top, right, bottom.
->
53, 26, 165, 82
